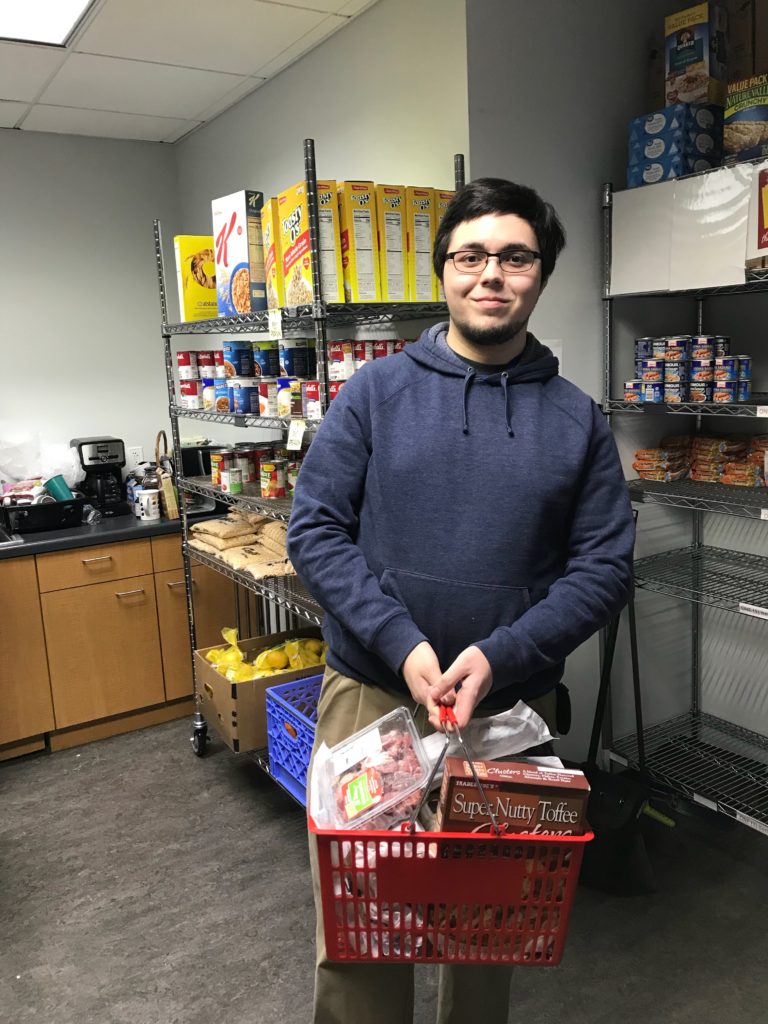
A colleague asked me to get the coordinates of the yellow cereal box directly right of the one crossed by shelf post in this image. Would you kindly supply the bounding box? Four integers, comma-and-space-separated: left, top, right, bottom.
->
337, 181, 381, 302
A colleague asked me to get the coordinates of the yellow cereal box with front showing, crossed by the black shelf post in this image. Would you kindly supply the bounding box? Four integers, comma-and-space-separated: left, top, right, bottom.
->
278, 181, 344, 306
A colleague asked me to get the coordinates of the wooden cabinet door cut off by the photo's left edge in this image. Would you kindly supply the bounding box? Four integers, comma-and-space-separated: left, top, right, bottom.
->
0, 557, 55, 746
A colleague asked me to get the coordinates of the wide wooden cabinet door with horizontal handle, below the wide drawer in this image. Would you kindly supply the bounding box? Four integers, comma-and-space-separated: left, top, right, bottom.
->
41, 577, 165, 729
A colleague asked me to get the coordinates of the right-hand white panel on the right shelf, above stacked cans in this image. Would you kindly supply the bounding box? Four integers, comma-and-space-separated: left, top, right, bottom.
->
670, 164, 753, 291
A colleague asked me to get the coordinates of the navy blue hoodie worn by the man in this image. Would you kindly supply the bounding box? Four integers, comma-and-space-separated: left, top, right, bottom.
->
288, 324, 635, 708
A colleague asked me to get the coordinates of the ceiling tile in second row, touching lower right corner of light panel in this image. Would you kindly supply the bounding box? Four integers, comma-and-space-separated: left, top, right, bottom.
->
40, 53, 246, 119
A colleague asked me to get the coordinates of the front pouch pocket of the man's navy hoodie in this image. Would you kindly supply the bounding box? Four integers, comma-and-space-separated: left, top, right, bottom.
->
381, 568, 530, 669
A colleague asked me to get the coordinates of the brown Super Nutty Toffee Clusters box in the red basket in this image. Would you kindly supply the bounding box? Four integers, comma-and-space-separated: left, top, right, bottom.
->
437, 758, 590, 836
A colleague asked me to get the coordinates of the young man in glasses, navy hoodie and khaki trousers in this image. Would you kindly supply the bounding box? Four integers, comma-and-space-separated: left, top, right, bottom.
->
288, 178, 634, 1024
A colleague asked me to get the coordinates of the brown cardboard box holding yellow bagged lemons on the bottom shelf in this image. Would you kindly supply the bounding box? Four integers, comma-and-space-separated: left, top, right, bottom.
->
195, 627, 323, 754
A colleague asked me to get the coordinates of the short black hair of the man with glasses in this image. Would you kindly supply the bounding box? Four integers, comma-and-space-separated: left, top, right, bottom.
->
432, 178, 565, 285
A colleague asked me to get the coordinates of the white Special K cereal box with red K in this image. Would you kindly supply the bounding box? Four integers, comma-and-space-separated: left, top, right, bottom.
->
211, 190, 266, 316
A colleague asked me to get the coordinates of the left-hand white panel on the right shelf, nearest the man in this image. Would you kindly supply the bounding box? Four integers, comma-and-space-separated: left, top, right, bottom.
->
609, 181, 675, 295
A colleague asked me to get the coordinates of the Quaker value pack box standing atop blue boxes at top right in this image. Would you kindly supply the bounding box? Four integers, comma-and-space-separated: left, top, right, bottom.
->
664, 3, 727, 105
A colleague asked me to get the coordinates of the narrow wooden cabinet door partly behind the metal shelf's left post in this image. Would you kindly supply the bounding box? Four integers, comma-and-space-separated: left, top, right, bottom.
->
153, 561, 236, 700
